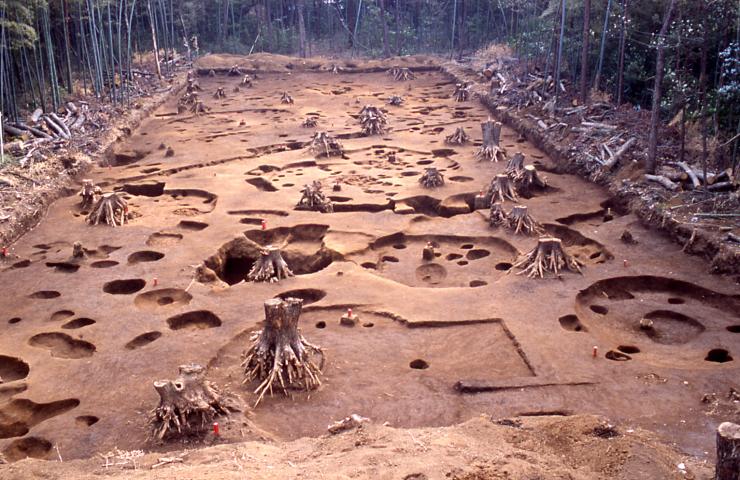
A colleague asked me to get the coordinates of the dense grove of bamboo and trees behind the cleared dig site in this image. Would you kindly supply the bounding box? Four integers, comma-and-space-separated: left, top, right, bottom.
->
0, 0, 740, 159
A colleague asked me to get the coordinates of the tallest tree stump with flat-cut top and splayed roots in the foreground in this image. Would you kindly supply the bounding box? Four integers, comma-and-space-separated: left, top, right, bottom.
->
242, 298, 324, 407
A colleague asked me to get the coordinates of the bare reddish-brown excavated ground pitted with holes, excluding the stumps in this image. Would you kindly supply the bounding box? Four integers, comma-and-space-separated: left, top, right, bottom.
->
0, 56, 740, 478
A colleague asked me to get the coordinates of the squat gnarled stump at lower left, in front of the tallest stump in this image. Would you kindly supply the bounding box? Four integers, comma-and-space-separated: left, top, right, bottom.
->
149, 364, 234, 440
